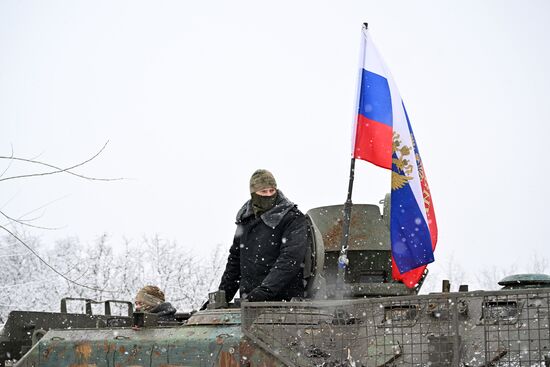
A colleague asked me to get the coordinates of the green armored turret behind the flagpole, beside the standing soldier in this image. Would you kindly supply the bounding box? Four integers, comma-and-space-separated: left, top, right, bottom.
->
307, 200, 420, 299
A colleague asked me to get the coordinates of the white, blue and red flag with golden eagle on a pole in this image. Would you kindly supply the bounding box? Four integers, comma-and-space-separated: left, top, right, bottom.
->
353, 26, 437, 288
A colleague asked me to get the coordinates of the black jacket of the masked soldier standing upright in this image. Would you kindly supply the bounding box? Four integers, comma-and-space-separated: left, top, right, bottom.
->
219, 191, 307, 301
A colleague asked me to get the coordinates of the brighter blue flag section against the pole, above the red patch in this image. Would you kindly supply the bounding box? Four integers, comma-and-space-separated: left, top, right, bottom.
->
358, 69, 393, 126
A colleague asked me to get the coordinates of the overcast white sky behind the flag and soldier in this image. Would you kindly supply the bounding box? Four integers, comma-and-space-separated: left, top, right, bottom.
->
0, 0, 550, 292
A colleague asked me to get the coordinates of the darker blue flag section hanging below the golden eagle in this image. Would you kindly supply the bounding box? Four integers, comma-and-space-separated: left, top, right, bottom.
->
390, 178, 434, 273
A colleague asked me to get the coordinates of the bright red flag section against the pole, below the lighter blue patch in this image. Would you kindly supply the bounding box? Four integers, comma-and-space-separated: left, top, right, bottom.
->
353, 115, 393, 169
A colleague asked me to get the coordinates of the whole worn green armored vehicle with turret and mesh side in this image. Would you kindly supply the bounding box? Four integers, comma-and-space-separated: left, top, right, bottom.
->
0, 201, 550, 367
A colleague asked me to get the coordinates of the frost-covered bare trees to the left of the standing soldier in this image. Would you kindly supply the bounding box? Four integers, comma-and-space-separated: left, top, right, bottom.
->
0, 232, 226, 324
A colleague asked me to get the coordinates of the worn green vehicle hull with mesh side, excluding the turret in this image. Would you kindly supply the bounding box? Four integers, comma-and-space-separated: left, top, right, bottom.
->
12, 288, 550, 367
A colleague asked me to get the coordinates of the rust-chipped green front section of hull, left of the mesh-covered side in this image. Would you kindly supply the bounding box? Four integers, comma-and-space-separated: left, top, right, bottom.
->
17, 309, 282, 367
